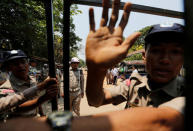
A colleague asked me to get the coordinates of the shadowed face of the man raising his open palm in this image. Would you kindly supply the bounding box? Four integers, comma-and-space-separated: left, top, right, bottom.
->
145, 42, 184, 83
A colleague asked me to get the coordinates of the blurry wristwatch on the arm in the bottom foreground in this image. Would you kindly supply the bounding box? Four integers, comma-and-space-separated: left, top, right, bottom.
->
47, 111, 73, 131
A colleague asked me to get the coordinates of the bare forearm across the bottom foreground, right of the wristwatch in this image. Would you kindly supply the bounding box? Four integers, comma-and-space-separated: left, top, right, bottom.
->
72, 107, 184, 131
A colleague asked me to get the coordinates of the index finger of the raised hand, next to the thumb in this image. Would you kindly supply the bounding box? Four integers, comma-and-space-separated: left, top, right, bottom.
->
119, 2, 132, 32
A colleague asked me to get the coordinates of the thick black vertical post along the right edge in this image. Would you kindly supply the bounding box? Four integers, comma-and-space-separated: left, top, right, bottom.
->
184, 0, 193, 131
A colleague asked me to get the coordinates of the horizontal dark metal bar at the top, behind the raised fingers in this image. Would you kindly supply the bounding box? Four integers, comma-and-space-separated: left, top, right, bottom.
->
71, 0, 183, 19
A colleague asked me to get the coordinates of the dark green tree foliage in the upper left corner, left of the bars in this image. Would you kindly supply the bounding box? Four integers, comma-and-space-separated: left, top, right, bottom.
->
0, 0, 46, 54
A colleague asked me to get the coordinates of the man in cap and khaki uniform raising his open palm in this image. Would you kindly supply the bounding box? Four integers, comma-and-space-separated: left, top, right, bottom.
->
86, 0, 185, 112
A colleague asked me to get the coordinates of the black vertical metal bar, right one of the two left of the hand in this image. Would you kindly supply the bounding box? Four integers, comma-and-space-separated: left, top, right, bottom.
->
63, 0, 70, 110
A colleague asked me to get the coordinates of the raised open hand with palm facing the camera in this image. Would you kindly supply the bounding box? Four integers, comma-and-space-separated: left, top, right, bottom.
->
86, 0, 140, 70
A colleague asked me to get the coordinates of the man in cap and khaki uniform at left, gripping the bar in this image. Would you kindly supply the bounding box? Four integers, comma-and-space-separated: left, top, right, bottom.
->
0, 50, 57, 119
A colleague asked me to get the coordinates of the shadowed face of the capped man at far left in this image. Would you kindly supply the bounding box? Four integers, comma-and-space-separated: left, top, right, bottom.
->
9, 58, 29, 80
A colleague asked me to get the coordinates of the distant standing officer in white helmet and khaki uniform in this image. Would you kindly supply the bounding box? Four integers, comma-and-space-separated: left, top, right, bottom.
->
69, 57, 84, 116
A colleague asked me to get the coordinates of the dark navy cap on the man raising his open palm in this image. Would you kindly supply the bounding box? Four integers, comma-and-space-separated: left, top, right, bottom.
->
145, 23, 185, 45
